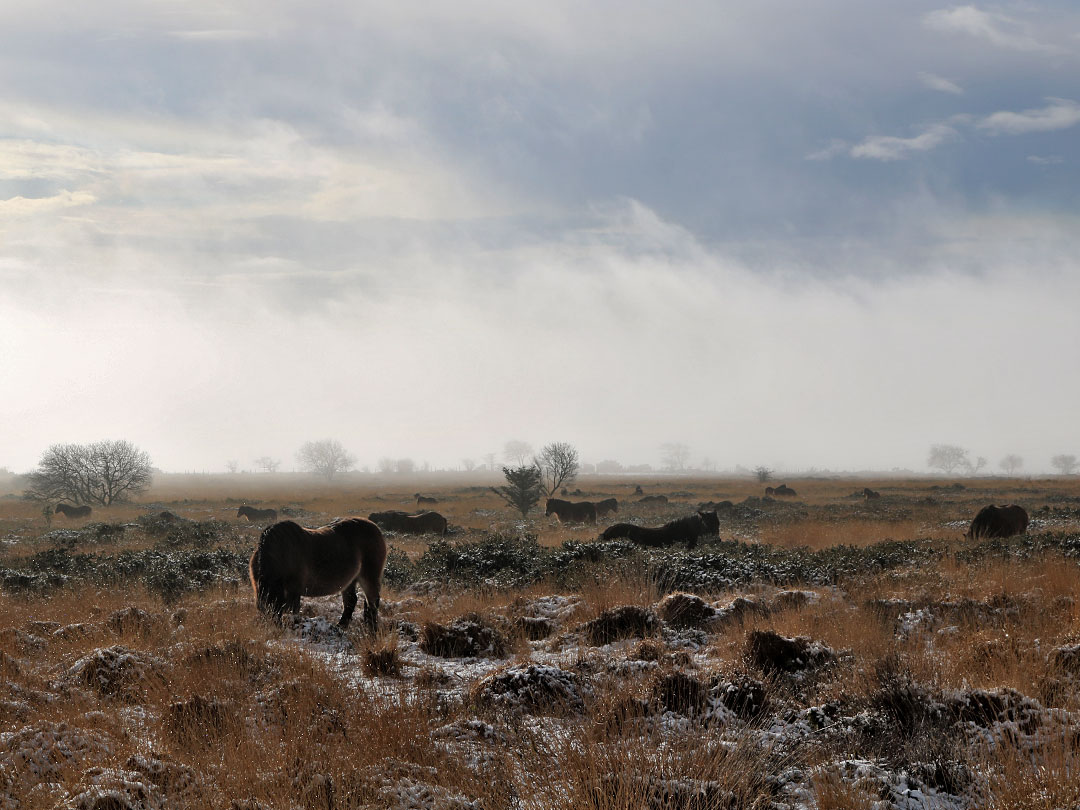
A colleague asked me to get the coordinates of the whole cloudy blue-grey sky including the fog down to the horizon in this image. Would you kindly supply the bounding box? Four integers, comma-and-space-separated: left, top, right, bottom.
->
0, 0, 1080, 472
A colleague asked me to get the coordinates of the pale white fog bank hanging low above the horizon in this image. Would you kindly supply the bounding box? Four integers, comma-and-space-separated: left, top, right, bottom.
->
0, 203, 1080, 473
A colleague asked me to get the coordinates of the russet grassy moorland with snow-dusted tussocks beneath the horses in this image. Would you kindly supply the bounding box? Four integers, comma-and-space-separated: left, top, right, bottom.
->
0, 475, 1080, 810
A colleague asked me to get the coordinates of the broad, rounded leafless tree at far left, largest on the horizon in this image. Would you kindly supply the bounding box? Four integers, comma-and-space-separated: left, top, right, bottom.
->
26, 440, 153, 507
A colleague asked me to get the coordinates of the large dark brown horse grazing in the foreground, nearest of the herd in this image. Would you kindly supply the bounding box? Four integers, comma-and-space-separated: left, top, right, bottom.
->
248, 517, 387, 633
